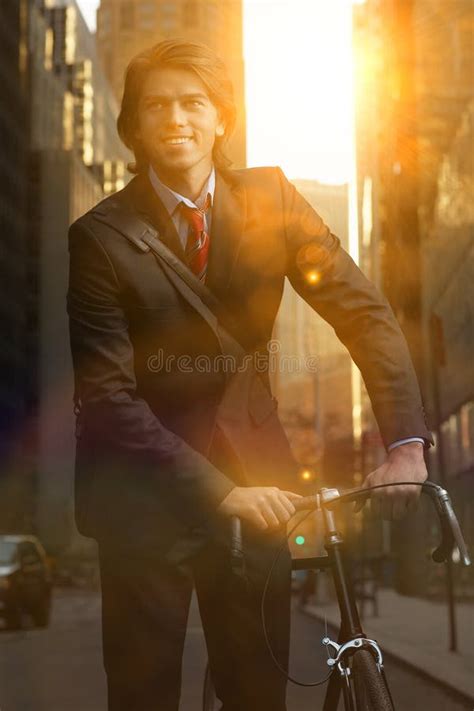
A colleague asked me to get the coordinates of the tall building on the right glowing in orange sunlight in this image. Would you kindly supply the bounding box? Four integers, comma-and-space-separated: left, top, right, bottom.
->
354, 0, 474, 594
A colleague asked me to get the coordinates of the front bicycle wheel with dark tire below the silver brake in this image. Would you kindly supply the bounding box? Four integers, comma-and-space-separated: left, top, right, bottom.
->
350, 649, 394, 711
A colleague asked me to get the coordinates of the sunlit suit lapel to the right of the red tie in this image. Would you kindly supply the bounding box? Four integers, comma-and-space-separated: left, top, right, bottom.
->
206, 171, 246, 298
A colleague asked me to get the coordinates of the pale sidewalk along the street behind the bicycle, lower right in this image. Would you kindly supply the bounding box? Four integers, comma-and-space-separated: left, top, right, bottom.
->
303, 590, 474, 702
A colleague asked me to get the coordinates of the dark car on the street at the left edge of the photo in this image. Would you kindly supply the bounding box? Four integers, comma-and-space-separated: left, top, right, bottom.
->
0, 535, 52, 629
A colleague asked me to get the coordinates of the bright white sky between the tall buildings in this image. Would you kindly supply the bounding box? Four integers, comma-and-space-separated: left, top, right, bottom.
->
78, 0, 353, 183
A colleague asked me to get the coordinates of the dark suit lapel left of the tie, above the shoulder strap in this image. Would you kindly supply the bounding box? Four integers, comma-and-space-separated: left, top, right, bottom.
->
128, 174, 185, 261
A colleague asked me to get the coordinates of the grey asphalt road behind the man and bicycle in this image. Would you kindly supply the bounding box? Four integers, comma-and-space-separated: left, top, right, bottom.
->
0, 590, 469, 711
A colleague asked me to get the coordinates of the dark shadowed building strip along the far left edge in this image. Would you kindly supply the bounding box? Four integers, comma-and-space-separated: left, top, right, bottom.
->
0, 0, 34, 536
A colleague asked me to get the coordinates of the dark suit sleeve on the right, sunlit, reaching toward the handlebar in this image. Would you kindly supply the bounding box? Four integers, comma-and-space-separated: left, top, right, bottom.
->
278, 169, 433, 447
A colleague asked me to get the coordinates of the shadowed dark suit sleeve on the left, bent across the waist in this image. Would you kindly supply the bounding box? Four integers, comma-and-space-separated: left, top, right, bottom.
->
67, 220, 235, 525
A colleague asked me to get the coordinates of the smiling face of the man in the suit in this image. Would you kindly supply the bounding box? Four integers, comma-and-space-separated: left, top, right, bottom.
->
131, 68, 225, 174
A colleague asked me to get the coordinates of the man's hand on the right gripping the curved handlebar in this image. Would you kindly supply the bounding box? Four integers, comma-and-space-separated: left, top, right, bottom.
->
355, 442, 428, 521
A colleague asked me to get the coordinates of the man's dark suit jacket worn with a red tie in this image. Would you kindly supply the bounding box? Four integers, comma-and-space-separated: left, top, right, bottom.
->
68, 168, 431, 550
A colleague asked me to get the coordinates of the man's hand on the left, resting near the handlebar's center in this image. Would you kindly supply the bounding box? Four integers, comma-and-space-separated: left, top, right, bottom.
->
217, 486, 302, 531
